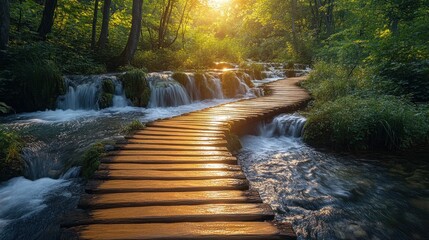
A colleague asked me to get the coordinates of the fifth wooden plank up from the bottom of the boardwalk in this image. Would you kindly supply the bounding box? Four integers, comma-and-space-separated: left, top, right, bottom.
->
93, 170, 246, 180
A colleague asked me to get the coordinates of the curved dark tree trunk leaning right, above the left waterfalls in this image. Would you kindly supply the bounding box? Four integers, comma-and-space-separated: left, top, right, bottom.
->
111, 0, 143, 68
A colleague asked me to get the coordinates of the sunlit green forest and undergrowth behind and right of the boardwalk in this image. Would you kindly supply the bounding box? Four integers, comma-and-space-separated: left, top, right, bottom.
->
0, 0, 429, 165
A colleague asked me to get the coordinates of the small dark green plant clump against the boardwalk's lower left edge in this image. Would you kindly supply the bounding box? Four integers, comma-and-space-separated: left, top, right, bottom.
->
79, 142, 104, 179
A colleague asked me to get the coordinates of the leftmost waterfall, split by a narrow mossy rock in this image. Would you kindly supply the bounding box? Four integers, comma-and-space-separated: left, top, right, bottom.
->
57, 75, 128, 110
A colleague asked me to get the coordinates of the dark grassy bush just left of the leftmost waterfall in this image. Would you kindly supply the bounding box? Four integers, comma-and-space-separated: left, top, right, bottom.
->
9, 61, 66, 111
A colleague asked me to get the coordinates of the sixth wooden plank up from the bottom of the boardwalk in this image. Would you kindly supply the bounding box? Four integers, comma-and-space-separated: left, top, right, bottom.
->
98, 163, 241, 171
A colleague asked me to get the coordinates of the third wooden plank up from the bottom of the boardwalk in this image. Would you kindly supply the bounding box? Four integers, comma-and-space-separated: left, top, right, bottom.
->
79, 190, 262, 209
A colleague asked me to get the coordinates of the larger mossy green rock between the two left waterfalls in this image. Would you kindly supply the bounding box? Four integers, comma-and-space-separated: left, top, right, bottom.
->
121, 70, 150, 107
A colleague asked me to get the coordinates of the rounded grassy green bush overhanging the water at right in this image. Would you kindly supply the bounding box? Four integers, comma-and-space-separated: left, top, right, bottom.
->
304, 96, 429, 150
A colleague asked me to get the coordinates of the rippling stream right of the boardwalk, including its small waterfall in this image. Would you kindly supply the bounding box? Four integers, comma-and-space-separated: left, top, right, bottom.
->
238, 114, 429, 239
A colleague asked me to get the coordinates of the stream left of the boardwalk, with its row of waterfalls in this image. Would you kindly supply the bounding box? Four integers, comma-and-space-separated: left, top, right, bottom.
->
0, 68, 281, 240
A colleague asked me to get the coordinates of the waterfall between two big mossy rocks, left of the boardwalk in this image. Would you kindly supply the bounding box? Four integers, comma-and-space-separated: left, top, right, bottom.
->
148, 74, 192, 108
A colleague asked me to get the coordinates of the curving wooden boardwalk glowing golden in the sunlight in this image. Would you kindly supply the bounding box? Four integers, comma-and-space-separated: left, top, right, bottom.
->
62, 78, 309, 240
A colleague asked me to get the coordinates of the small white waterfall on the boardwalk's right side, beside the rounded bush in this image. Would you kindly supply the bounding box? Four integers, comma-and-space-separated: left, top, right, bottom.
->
259, 114, 306, 138
